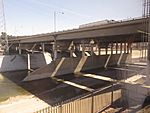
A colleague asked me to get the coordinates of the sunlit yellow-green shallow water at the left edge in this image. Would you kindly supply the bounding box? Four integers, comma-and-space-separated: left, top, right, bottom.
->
0, 73, 29, 102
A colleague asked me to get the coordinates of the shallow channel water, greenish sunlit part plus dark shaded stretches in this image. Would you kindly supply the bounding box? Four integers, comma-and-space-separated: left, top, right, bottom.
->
0, 64, 145, 104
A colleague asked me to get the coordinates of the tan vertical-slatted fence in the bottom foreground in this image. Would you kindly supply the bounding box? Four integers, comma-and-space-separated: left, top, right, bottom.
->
34, 84, 122, 113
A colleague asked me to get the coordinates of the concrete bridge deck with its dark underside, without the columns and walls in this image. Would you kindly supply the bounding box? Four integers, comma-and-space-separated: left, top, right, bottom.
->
9, 18, 148, 56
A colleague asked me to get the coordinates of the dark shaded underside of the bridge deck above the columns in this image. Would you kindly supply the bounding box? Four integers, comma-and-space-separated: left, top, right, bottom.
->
9, 33, 142, 56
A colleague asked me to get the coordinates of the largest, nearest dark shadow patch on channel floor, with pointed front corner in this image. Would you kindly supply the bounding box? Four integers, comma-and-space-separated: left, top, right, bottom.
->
2, 71, 87, 105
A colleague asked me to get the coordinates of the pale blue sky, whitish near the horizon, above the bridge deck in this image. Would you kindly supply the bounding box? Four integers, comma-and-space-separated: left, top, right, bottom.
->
4, 0, 142, 35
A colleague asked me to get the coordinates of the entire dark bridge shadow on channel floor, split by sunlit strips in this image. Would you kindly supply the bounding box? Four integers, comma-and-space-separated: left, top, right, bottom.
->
2, 55, 143, 105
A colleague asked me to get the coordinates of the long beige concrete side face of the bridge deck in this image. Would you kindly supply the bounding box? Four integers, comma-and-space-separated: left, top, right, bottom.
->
9, 19, 144, 43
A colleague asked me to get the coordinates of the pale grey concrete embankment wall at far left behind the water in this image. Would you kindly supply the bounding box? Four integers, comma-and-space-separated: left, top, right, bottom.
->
0, 53, 52, 72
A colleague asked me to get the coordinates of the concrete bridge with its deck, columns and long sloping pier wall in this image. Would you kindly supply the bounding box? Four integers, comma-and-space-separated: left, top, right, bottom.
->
0, 18, 148, 81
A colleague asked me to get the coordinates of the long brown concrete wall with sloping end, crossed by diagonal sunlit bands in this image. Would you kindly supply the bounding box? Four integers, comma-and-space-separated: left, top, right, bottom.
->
24, 53, 131, 81
